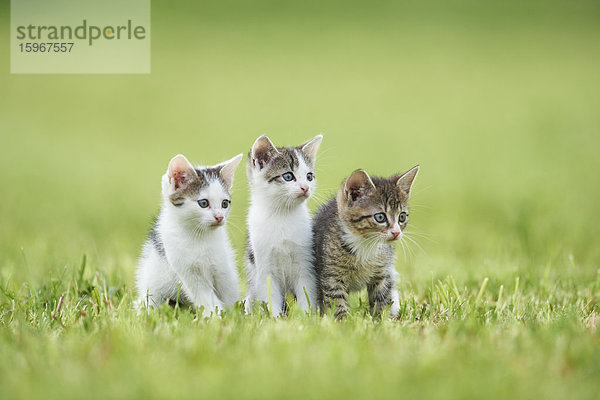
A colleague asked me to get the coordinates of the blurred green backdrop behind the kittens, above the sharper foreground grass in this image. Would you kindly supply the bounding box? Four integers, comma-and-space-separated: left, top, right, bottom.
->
0, 0, 600, 397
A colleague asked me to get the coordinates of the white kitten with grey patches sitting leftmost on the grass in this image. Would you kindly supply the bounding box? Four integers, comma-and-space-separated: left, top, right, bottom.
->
137, 154, 242, 316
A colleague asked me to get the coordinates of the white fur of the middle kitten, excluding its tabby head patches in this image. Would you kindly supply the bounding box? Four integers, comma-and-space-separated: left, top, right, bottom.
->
246, 141, 321, 316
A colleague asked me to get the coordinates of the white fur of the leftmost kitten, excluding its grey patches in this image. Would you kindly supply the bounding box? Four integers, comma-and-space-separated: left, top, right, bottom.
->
137, 154, 241, 316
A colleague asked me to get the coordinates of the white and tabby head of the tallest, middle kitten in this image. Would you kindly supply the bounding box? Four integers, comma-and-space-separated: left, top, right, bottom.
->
246, 135, 323, 209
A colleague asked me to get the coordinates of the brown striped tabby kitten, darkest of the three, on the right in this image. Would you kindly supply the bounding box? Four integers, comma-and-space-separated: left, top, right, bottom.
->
313, 166, 419, 319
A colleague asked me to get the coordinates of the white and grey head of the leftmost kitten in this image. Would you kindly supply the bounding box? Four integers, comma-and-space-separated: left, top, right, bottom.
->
162, 154, 242, 229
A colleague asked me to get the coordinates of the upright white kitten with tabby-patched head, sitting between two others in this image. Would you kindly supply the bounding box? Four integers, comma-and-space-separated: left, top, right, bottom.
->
246, 135, 323, 316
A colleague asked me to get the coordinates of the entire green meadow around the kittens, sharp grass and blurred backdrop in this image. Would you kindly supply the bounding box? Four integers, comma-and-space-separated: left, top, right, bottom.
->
0, 1, 600, 399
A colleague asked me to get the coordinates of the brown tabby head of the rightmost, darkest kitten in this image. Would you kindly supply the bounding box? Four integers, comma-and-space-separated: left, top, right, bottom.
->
337, 165, 419, 242
